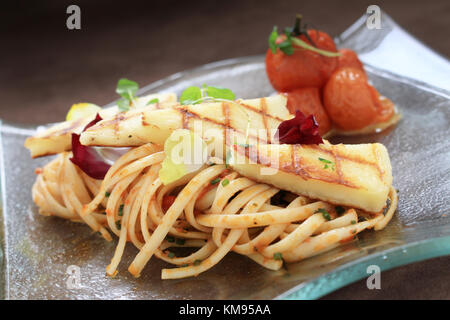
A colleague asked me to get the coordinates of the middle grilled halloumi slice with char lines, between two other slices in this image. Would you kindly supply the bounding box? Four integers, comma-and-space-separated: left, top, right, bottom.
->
80, 95, 292, 151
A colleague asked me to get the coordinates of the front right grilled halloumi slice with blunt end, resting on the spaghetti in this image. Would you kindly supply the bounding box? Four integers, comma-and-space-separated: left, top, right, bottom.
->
230, 143, 392, 212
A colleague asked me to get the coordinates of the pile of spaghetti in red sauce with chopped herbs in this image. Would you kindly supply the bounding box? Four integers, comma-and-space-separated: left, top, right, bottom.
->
32, 143, 397, 279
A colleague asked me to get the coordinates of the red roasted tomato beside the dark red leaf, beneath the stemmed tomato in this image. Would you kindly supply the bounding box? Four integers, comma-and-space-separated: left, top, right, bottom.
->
285, 87, 331, 136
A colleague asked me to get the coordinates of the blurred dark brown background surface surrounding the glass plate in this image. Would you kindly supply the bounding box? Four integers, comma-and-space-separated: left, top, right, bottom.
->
0, 0, 450, 299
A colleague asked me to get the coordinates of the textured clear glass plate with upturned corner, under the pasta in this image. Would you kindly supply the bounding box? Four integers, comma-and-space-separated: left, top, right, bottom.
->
0, 13, 450, 299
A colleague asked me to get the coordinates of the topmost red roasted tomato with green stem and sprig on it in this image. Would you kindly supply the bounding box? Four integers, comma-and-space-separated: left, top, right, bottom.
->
266, 30, 338, 92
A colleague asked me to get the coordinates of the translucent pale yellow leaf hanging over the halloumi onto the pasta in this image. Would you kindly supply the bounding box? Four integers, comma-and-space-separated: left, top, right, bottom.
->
159, 129, 208, 185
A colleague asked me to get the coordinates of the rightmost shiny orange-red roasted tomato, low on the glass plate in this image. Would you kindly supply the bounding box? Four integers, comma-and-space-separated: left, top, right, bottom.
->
323, 67, 393, 130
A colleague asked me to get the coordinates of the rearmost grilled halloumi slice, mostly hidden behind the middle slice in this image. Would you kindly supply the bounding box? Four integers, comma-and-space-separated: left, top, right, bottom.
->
25, 93, 177, 158
